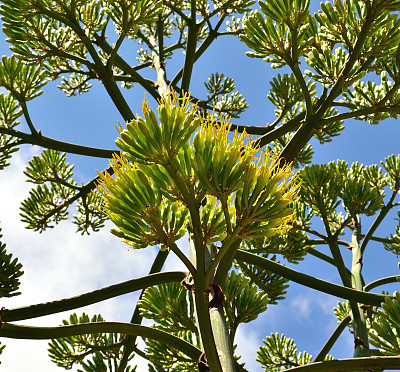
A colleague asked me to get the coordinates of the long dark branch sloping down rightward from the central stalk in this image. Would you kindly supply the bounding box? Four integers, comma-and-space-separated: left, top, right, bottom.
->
235, 249, 386, 306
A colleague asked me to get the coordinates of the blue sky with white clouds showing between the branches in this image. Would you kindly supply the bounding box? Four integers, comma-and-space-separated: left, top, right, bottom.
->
0, 2, 400, 372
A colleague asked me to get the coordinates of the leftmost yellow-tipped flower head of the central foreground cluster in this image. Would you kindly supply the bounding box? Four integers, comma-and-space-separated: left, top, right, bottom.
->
98, 156, 188, 248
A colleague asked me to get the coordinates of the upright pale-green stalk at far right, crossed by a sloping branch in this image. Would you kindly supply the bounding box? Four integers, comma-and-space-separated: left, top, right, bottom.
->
350, 216, 370, 358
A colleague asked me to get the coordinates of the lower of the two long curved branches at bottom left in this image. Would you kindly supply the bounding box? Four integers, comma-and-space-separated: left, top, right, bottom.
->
0, 322, 201, 360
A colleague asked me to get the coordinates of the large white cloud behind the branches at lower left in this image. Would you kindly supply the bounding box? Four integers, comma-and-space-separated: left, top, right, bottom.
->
0, 150, 156, 372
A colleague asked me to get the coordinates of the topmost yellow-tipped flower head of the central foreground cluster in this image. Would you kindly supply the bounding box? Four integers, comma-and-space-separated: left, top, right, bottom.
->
115, 92, 200, 164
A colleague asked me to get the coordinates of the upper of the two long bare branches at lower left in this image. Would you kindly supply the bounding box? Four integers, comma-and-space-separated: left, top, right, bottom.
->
1, 271, 187, 322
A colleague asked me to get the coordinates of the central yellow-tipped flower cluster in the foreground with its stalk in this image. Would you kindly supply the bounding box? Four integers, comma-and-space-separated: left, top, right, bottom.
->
99, 94, 299, 371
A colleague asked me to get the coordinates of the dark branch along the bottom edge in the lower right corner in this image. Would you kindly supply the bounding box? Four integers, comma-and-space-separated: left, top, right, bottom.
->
283, 356, 400, 372
